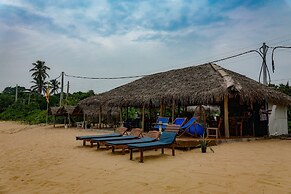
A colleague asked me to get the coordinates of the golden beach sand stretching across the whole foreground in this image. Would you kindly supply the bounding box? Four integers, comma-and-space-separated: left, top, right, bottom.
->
0, 122, 291, 194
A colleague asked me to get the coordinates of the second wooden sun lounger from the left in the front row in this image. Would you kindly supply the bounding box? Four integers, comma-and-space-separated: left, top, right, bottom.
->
90, 128, 143, 149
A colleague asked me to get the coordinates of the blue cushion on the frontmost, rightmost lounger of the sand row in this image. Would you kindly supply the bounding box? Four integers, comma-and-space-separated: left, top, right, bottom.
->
128, 132, 177, 148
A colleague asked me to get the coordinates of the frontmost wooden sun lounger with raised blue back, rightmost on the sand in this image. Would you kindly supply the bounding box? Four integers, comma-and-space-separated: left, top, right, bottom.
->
127, 132, 177, 162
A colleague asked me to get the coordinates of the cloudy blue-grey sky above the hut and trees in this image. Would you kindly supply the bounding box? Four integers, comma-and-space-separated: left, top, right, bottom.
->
0, 0, 291, 93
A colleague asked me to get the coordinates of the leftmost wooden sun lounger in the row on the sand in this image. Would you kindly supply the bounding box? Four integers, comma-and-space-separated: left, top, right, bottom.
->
76, 127, 127, 146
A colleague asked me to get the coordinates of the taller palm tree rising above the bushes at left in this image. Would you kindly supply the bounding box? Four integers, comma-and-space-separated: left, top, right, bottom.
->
29, 60, 50, 94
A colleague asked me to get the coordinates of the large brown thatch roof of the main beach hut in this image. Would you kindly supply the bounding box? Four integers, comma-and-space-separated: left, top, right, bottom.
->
78, 64, 291, 107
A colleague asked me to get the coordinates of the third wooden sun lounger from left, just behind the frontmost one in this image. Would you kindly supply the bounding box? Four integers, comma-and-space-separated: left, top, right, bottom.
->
106, 130, 160, 154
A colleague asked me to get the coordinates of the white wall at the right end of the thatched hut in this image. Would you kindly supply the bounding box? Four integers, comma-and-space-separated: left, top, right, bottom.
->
268, 103, 288, 135
